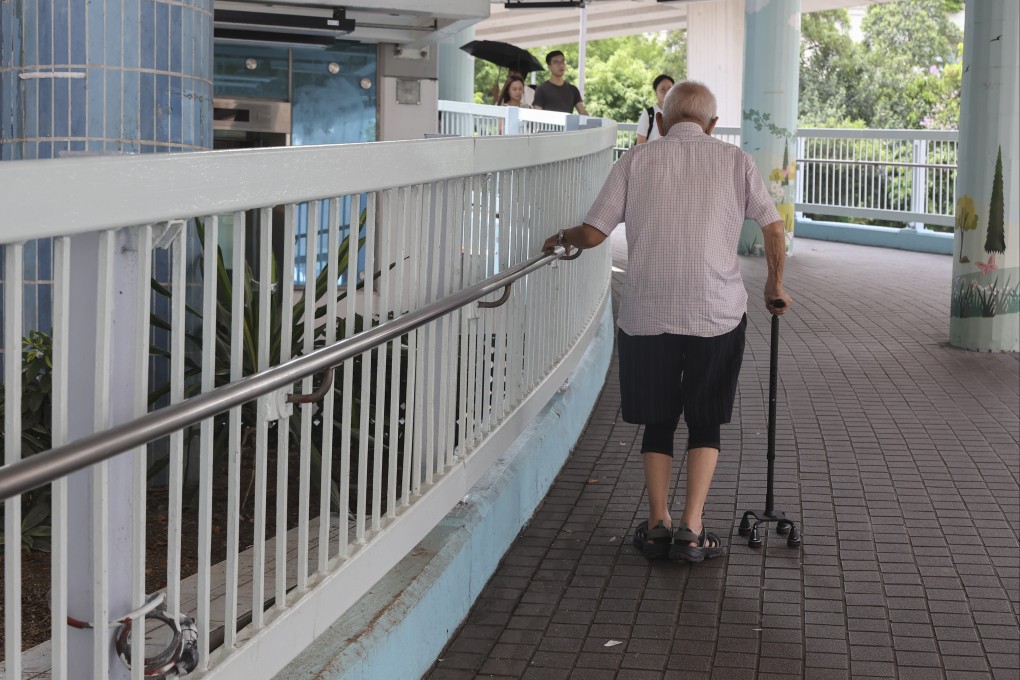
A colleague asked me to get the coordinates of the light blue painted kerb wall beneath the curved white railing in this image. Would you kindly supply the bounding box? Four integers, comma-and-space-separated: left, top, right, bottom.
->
276, 304, 614, 680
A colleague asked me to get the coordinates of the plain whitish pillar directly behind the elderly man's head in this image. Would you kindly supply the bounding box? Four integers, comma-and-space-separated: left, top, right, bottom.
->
685, 0, 744, 127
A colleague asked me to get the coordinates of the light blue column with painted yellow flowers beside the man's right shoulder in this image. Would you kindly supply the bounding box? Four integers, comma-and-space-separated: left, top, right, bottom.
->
737, 0, 801, 255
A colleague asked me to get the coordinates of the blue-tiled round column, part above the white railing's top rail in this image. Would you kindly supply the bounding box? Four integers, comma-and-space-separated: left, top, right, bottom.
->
0, 0, 212, 160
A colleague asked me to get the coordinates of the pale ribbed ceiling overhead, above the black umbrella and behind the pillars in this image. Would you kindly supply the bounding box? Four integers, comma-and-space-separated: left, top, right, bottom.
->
474, 0, 889, 47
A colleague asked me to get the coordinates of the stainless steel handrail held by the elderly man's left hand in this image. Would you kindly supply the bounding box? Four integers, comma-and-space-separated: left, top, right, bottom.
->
0, 246, 572, 501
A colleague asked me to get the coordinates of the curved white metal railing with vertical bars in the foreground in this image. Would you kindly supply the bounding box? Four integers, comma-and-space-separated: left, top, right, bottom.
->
0, 125, 615, 678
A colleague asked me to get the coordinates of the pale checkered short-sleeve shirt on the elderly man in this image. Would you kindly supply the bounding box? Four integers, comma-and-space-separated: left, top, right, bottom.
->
584, 122, 781, 337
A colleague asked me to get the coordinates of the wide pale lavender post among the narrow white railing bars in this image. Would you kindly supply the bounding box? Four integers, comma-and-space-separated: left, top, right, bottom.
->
66, 229, 148, 679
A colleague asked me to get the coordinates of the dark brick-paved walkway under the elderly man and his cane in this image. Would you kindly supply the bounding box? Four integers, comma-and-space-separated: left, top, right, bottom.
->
426, 240, 1020, 680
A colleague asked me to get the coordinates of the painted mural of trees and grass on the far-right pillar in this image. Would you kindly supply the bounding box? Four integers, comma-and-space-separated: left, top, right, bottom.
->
951, 146, 1020, 318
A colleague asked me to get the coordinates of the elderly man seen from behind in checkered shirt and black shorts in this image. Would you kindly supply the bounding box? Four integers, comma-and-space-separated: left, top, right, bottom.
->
545, 82, 792, 562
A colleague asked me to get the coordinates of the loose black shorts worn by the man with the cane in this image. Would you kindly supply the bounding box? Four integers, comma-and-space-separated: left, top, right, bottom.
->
617, 314, 748, 425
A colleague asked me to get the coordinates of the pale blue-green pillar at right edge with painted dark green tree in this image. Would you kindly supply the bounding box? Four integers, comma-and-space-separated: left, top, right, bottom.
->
950, 0, 1020, 352
